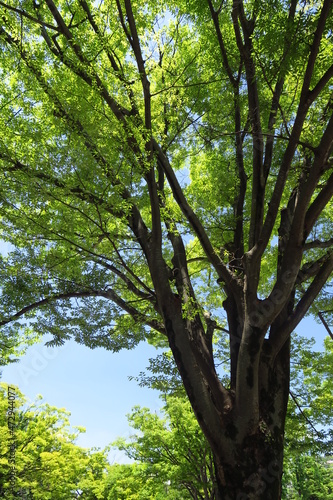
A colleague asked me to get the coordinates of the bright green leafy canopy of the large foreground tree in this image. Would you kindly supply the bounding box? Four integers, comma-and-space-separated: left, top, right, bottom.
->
0, 0, 333, 368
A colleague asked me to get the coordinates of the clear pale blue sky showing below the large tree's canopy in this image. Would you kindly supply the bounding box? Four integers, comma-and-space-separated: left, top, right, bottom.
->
2, 312, 326, 463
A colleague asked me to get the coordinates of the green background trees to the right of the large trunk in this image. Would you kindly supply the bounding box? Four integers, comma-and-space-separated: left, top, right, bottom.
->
283, 337, 333, 500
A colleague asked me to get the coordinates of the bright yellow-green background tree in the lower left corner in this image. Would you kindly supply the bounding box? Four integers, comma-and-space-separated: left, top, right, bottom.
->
0, 384, 108, 500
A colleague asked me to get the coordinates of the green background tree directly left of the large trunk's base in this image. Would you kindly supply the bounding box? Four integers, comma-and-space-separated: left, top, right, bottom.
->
114, 396, 215, 500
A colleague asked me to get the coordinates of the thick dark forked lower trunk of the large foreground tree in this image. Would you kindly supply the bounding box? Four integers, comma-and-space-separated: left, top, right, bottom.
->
160, 254, 289, 500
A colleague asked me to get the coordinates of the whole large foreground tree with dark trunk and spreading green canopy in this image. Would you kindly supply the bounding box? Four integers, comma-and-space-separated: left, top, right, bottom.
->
0, 0, 333, 500
